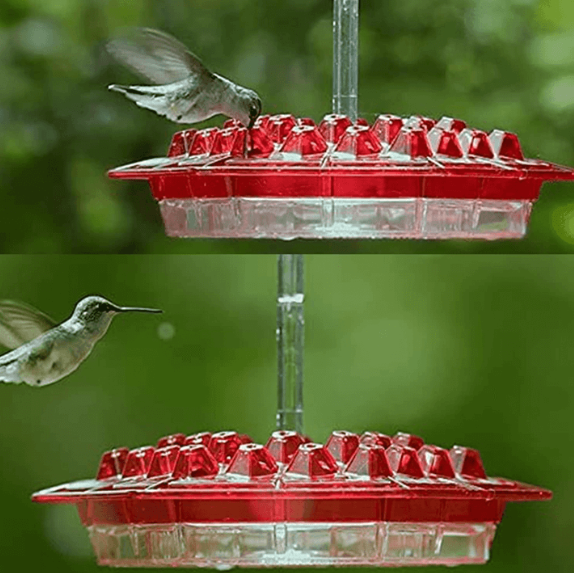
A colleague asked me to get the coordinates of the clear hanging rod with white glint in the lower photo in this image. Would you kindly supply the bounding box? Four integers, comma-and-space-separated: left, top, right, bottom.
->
277, 255, 305, 434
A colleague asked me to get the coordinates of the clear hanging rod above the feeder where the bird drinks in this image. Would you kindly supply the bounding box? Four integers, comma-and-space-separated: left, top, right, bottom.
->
333, 0, 359, 121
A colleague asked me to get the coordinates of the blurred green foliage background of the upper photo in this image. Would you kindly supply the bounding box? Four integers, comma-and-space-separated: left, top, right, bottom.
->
0, 0, 574, 253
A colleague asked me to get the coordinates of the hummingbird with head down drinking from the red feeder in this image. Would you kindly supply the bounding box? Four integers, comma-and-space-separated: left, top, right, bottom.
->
107, 28, 261, 128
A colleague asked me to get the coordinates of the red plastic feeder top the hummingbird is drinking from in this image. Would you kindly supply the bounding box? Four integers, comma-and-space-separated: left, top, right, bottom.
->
109, 114, 574, 200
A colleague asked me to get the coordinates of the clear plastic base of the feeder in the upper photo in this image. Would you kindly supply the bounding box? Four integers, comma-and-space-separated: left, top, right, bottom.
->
160, 197, 532, 240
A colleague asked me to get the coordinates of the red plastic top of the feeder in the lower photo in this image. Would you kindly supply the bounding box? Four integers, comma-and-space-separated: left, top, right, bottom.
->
33, 431, 552, 525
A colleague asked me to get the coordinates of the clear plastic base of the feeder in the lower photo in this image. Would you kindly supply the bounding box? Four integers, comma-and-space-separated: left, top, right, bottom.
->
88, 522, 496, 569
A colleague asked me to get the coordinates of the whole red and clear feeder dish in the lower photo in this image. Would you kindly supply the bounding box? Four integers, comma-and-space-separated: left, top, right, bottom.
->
33, 431, 552, 569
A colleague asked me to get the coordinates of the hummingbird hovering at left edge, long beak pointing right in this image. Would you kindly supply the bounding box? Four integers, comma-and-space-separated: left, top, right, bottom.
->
0, 296, 162, 387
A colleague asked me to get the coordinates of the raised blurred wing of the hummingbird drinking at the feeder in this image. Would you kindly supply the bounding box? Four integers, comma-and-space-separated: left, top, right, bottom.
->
107, 28, 214, 84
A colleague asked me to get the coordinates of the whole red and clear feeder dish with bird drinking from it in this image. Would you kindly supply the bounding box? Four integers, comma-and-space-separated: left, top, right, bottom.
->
109, 114, 574, 239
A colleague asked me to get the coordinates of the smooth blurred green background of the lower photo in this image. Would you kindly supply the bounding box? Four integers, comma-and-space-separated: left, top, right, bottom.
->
0, 255, 574, 573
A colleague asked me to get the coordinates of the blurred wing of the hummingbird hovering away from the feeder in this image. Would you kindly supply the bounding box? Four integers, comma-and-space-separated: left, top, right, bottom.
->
0, 300, 56, 349
